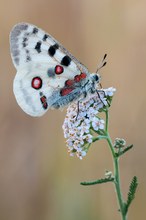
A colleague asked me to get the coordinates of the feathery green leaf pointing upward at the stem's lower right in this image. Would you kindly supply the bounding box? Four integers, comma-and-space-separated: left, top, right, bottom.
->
125, 176, 138, 213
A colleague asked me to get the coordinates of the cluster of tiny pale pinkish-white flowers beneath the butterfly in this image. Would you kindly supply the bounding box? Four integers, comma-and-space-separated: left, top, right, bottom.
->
62, 87, 115, 159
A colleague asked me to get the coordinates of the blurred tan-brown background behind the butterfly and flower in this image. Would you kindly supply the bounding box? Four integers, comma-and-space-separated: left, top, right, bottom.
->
0, 0, 146, 220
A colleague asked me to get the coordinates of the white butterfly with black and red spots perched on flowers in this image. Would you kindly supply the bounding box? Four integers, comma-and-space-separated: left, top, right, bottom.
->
10, 23, 106, 116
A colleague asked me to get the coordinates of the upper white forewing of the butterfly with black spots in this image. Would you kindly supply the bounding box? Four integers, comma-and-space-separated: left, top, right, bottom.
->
10, 23, 88, 74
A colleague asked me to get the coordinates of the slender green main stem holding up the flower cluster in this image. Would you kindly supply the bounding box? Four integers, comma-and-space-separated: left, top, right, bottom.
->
105, 110, 127, 220
